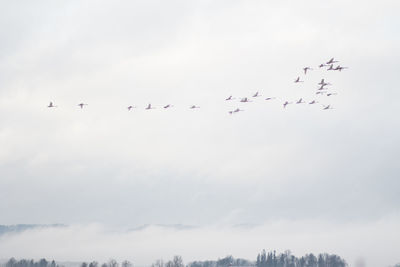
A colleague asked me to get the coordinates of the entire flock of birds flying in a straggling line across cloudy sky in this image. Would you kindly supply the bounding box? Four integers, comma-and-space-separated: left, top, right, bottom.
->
47, 58, 348, 114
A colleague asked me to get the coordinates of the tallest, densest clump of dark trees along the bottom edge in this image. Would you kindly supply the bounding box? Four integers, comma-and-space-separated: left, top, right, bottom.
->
256, 250, 347, 267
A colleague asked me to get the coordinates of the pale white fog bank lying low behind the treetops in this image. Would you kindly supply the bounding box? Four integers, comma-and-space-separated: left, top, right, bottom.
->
0, 221, 400, 266
